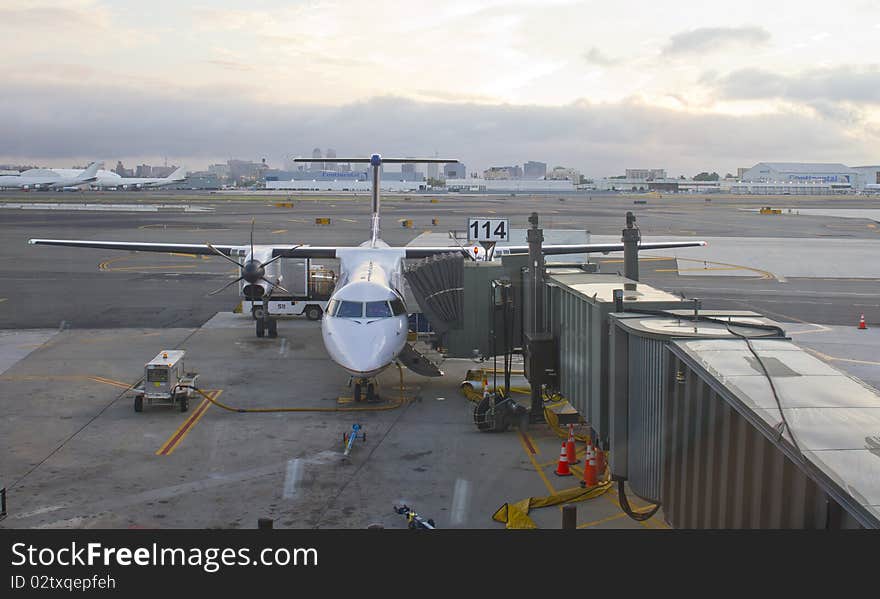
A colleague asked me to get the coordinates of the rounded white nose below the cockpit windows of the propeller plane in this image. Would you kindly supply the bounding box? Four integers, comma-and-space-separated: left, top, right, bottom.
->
321, 316, 408, 377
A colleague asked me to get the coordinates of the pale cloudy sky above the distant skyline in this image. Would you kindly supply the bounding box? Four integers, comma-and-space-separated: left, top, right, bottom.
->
0, 0, 880, 176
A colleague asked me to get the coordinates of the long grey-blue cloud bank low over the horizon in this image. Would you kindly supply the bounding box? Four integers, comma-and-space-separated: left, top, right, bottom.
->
0, 79, 872, 176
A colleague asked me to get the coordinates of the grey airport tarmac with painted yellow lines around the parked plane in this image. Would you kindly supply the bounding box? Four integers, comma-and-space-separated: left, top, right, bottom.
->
0, 192, 880, 528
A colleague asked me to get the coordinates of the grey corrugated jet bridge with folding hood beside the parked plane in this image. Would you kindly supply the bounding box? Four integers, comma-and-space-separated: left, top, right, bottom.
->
407, 215, 880, 529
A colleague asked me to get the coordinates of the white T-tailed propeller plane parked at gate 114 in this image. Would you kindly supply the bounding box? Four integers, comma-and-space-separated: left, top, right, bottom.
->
28, 154, 705, 401
